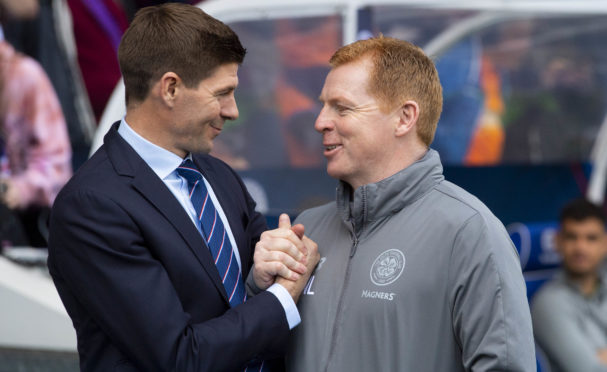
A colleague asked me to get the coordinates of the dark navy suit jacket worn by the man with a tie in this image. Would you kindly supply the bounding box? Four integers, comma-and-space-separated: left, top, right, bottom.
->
48, 124, 289, 372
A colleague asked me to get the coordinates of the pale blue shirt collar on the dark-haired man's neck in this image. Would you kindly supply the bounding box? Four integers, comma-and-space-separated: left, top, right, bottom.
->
118, 118, 185, 179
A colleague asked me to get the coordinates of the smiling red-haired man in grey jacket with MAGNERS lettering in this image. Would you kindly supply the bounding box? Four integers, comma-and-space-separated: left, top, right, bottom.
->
260, 37, 536, 372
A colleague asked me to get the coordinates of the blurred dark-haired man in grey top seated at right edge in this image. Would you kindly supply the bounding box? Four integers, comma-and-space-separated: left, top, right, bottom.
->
531, 199, 607, 372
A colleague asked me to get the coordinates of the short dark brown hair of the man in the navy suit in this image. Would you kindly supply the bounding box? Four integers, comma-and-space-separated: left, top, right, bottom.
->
118, 3, 246, 104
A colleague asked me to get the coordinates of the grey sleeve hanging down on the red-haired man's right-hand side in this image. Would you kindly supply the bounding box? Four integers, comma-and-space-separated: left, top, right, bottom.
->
449, 213, 536, 371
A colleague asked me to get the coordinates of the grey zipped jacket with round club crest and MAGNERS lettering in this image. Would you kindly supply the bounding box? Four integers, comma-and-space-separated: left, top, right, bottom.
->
287, 150, 536, 372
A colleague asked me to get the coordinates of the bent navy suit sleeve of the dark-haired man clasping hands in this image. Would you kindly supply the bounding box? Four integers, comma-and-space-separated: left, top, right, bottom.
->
49, 191, 288, 371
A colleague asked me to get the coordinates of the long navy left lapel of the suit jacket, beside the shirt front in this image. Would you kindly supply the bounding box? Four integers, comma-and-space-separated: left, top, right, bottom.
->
105, 125, 229, 306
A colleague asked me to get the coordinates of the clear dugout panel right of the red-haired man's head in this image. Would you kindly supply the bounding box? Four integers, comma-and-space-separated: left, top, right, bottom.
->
366, 7, 607, 165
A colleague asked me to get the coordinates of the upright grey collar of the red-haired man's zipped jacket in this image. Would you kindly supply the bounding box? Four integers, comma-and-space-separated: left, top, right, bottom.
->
337, 149, 445, 232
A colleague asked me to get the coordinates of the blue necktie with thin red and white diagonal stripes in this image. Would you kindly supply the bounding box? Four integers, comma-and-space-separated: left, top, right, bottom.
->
177, 159, 246, 307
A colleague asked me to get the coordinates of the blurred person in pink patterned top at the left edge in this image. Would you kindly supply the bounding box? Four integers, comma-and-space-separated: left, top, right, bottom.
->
0, 0, 72, 245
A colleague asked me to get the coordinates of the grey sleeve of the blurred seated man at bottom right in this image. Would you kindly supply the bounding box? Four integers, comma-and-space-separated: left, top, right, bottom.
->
531, 288, 607, 372
